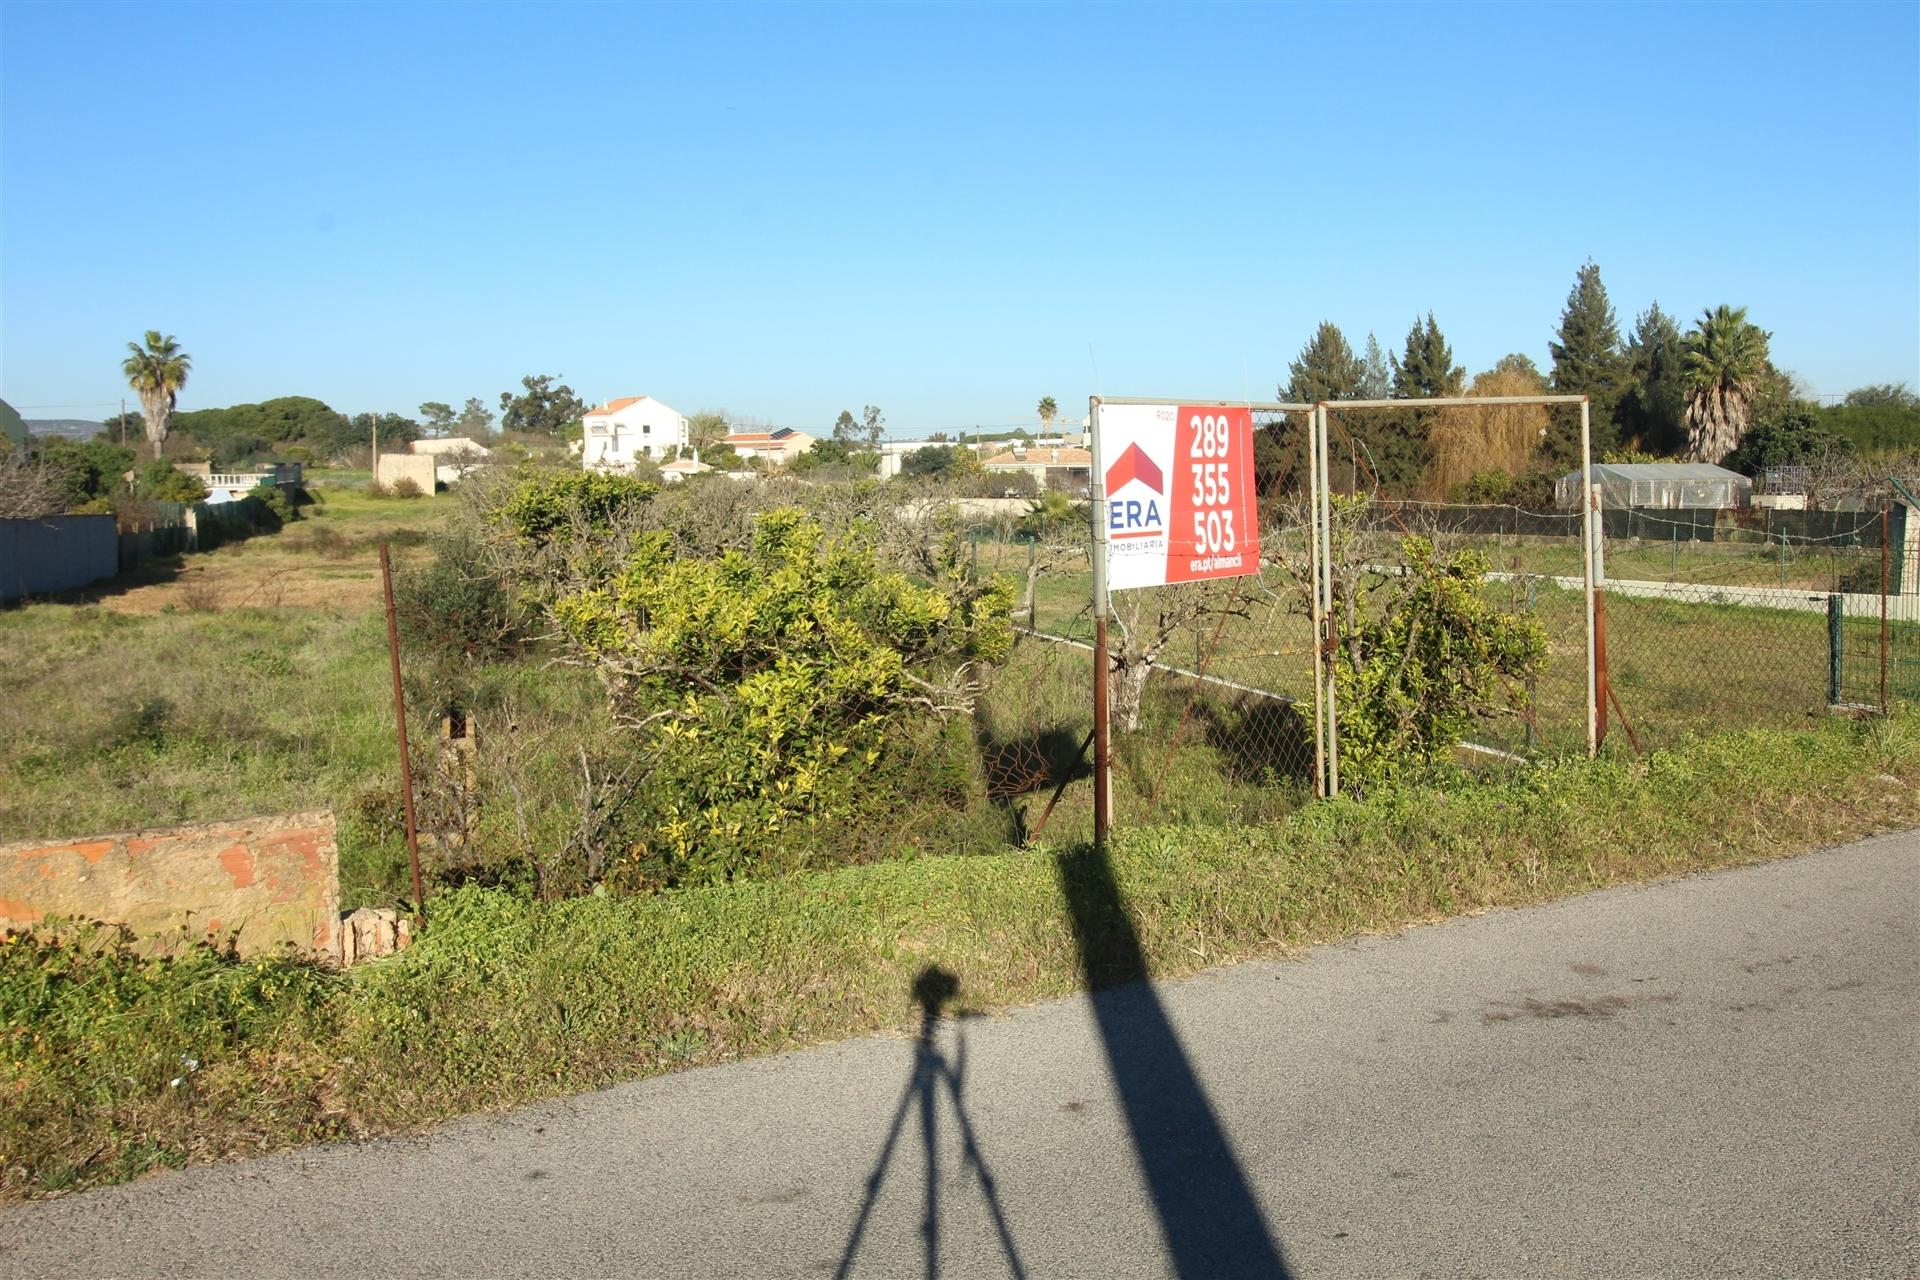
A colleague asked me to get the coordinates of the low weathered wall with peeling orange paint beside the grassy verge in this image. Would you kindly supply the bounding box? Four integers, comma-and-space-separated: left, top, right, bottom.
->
0, 810, 340, 961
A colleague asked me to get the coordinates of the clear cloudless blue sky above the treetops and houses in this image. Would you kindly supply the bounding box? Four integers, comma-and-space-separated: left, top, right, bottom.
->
0, 4, 1920, 436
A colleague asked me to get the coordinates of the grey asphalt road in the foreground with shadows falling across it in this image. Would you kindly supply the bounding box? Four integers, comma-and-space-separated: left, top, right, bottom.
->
0, 833, 1920, 1280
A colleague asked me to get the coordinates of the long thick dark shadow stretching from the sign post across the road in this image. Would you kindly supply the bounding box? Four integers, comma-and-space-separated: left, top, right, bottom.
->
1056, 848, 1290, 1280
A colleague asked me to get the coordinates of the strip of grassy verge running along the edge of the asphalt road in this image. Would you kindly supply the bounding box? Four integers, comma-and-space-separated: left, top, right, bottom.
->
0, 716, 1920, 1197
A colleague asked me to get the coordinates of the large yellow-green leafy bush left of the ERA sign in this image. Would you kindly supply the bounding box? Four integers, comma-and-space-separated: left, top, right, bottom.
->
551, 509, 1012, 885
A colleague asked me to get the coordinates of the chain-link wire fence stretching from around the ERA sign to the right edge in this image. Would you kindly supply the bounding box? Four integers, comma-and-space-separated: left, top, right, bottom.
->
929, 413, 1920, 842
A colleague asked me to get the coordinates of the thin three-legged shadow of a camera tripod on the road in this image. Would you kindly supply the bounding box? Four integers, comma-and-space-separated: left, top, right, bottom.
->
833, 965, 1027, 1280
